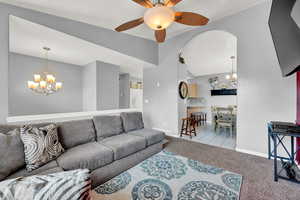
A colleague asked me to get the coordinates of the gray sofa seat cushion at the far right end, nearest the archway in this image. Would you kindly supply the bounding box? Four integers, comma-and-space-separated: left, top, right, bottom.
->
127, 129, 165, 146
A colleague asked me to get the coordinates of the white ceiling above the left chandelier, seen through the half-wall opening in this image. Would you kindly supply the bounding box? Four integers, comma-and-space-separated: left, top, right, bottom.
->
9, 16, 153, 78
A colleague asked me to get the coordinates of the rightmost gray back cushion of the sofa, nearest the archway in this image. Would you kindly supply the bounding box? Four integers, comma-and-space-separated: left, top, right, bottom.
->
121, 112, 144, 132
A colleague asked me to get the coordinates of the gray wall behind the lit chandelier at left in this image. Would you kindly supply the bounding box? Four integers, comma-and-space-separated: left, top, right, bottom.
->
9, 53, 82, 116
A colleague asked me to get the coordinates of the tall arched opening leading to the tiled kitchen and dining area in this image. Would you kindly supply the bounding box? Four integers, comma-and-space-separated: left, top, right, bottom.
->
178, 30, 238, 149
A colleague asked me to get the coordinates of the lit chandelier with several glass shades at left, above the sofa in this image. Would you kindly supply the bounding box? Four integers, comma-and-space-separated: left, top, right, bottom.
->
27, 47, 62, 96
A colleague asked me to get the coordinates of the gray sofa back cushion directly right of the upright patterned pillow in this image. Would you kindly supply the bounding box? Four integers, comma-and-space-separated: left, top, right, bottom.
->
57, 119, 96, 149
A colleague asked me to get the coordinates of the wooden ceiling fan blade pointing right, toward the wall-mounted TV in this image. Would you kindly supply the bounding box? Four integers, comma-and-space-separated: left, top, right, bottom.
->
175, 12, 209, 26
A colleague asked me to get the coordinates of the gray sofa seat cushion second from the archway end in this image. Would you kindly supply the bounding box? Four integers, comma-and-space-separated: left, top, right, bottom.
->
99, 134, 146, 160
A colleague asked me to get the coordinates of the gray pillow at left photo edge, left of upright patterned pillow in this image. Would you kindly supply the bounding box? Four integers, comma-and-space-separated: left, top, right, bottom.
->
0, 129, 25, 181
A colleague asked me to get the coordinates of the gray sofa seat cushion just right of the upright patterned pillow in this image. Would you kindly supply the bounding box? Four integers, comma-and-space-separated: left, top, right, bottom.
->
57, 142, 114, 170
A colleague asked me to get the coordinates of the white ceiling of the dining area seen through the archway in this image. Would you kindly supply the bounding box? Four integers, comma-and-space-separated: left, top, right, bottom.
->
182, 31, 238, 76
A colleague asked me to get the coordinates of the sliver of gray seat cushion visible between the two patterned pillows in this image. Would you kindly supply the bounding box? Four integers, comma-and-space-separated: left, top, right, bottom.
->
7, 160, 63, 179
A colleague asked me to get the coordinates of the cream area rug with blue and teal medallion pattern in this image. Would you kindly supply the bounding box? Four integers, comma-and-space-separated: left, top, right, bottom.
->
92, 151, 242, 200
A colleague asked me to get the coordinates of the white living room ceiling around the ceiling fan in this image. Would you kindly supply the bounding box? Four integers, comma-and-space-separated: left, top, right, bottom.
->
0, 0, 268, 39
